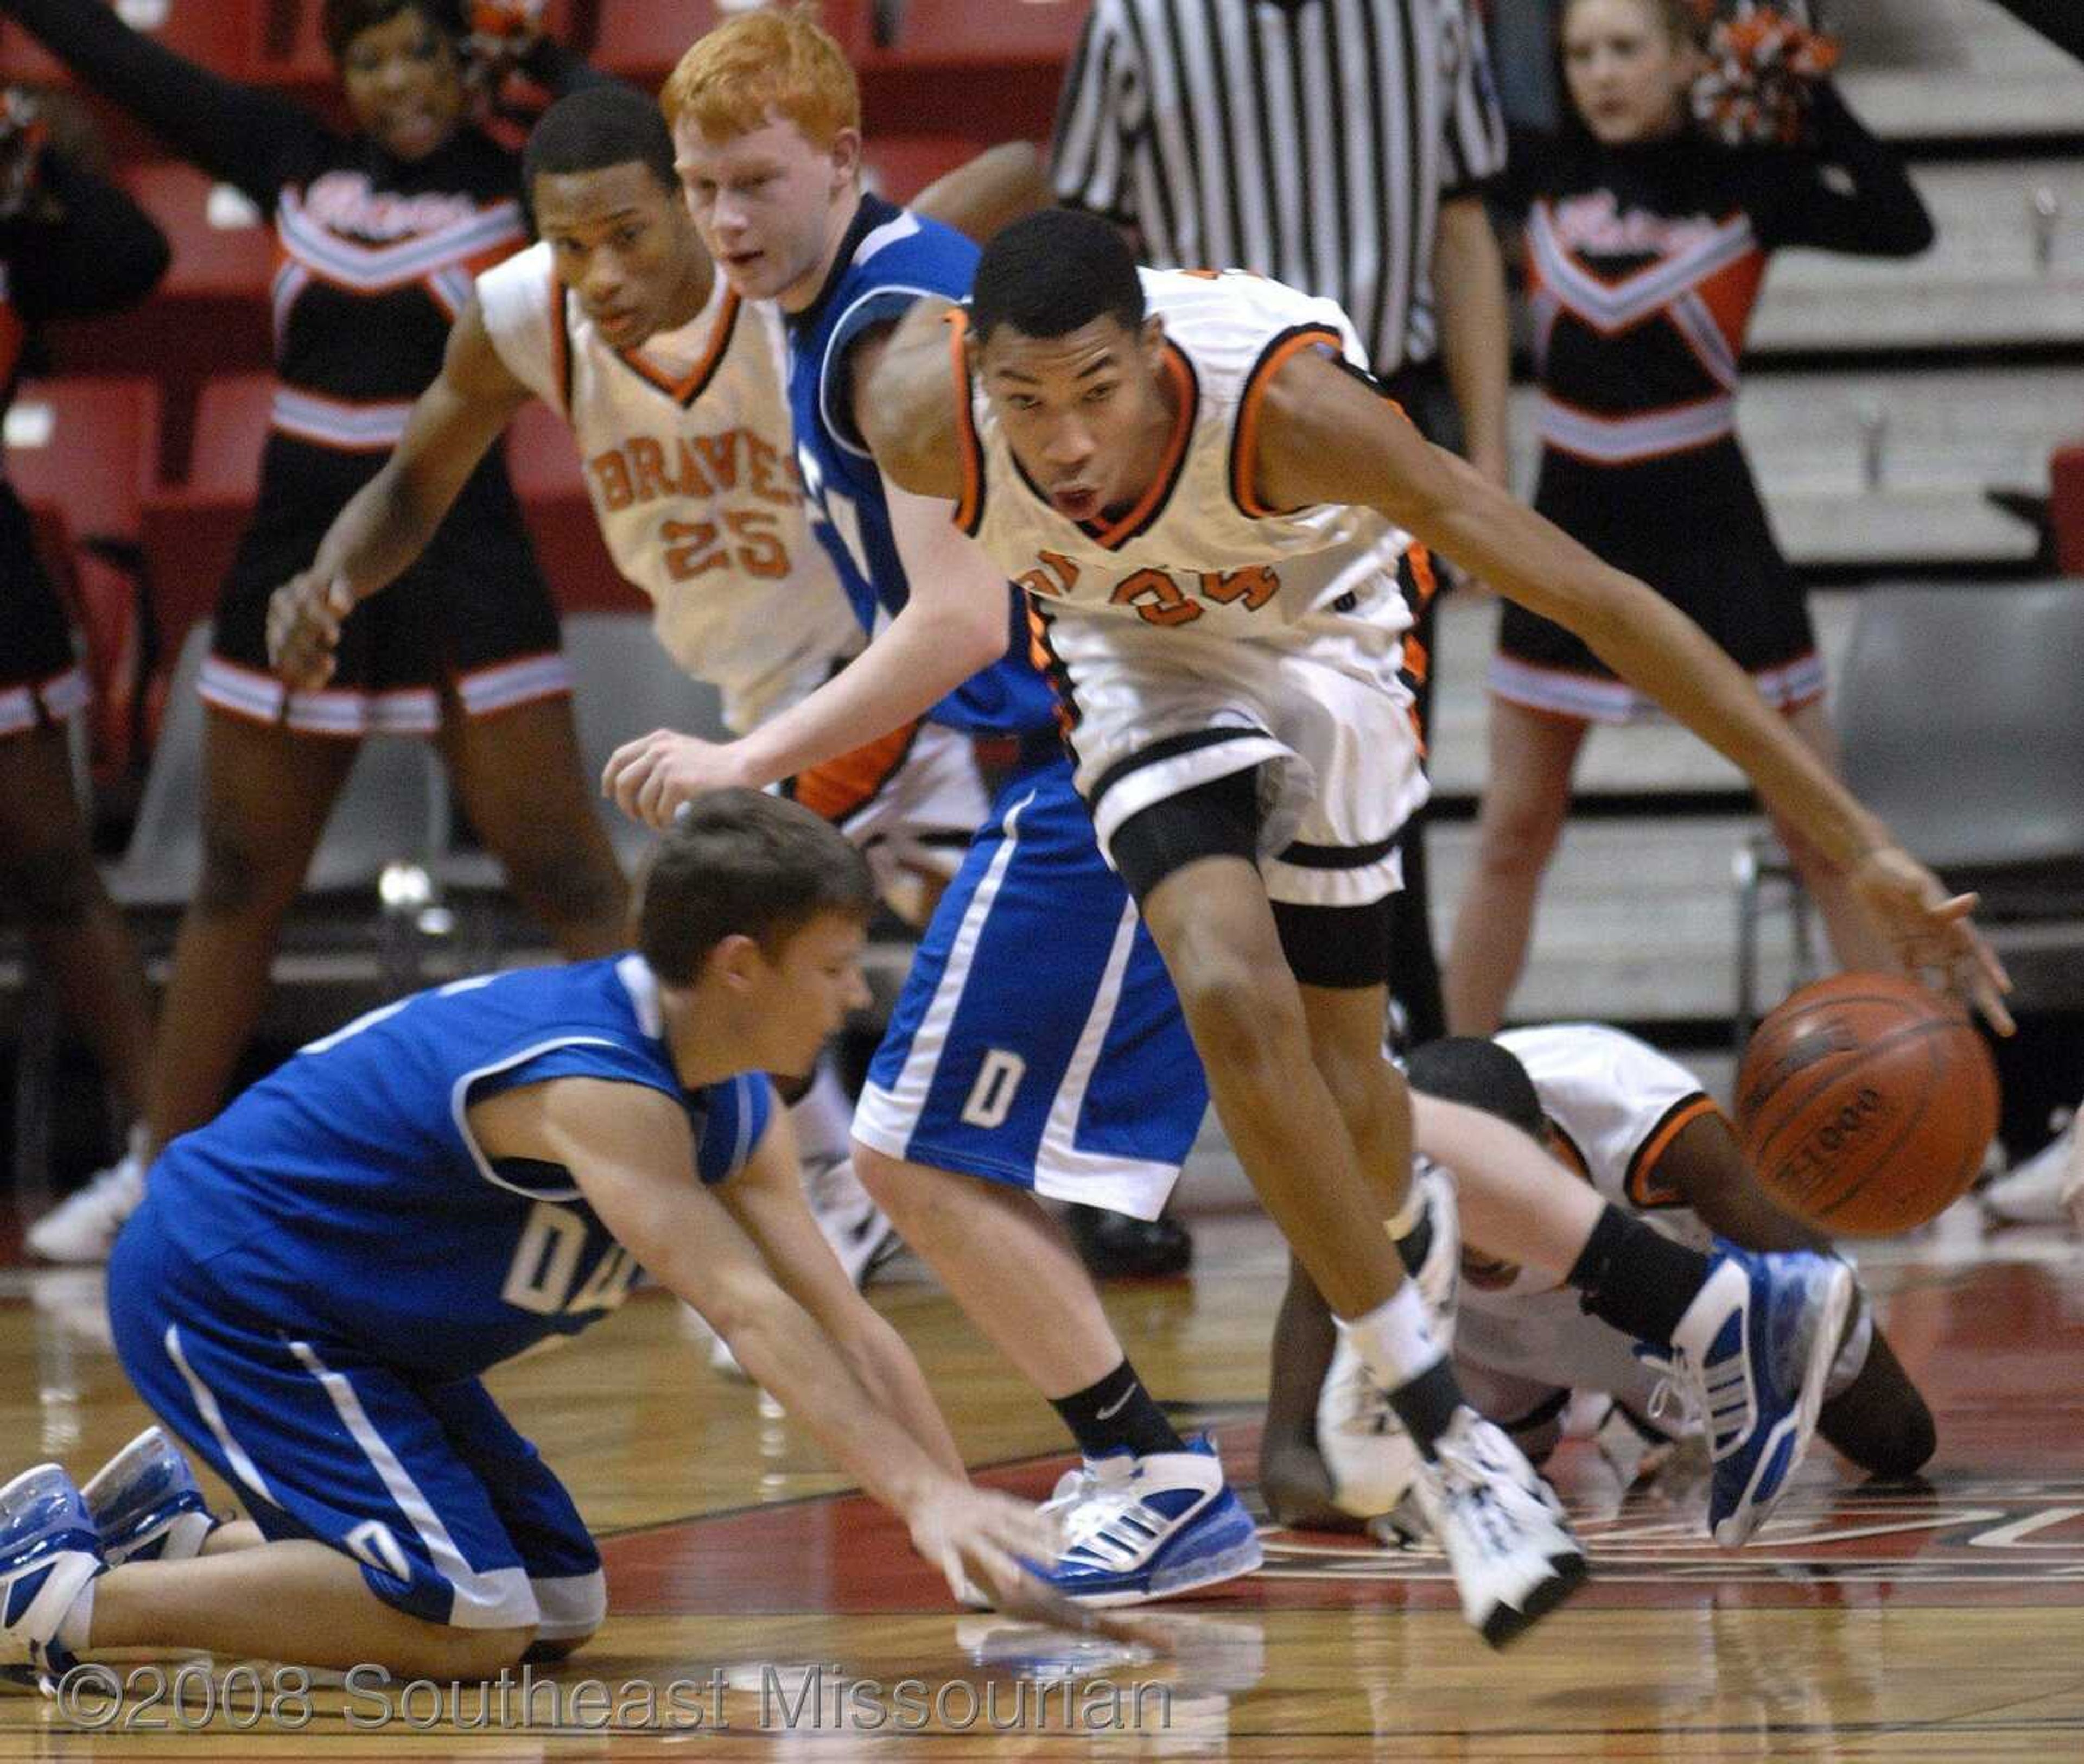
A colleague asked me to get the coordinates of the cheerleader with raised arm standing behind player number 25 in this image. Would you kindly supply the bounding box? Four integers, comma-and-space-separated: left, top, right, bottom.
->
0, 0, 625, 1261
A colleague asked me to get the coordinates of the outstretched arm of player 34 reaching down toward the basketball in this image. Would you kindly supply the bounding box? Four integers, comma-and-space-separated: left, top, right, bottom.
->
1255, 350, 2011, 1032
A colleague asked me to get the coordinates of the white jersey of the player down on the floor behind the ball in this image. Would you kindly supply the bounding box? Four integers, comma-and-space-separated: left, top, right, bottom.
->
1463, 1024, 1717, 1305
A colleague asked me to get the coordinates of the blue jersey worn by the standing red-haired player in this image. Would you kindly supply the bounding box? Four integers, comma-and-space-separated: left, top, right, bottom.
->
788, 196, 1057, 734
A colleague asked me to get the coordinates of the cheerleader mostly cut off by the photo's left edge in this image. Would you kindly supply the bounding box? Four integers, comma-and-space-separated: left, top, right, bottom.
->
0, 92, 167, 1184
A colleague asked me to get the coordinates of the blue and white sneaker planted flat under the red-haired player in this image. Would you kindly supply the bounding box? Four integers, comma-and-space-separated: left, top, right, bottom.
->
1035, 1432, 1265, 1606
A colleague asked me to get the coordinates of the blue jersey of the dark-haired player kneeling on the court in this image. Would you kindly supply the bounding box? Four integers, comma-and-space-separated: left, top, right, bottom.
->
148, 955, 771, 1376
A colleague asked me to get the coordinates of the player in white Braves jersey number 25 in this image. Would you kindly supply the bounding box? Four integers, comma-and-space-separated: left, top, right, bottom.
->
269, 86, 1016, 1292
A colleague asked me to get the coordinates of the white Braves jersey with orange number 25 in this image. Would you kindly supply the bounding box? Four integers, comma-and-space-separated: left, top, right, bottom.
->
477, 244, 863, 732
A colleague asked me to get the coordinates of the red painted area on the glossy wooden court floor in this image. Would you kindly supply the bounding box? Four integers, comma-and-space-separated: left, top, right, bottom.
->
605, 1264, 2084, 1616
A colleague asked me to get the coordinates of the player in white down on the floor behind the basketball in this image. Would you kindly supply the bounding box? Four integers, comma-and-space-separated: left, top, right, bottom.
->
1259, 1024, 1936, 1528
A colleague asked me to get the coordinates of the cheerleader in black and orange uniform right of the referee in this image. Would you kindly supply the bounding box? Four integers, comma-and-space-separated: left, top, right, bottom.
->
1446, 0, 1932, 1034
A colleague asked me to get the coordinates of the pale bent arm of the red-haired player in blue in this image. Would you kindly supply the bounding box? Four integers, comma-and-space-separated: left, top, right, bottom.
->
602, 321, 1013, 826
